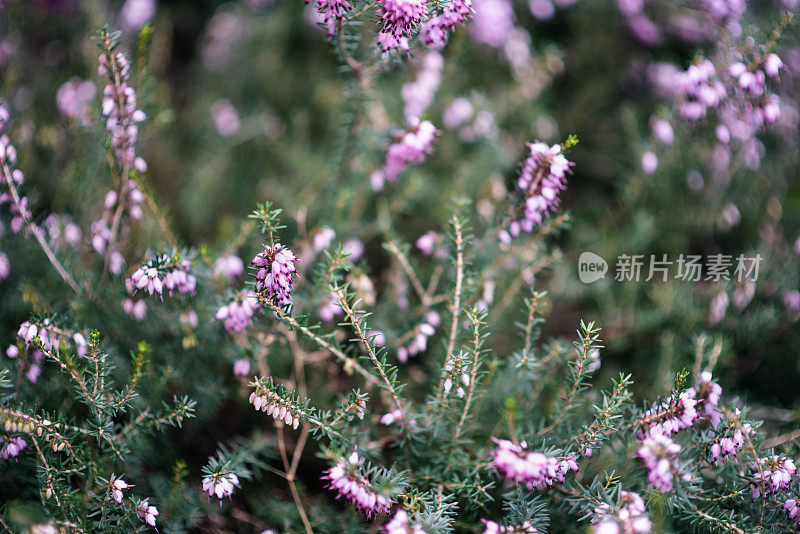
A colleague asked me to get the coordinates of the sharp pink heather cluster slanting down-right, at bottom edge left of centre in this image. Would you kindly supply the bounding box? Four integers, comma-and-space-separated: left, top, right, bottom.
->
322, 451, 394, 518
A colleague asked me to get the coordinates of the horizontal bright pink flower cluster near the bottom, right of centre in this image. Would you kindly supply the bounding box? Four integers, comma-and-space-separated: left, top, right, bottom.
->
492, 438, 578, 489
